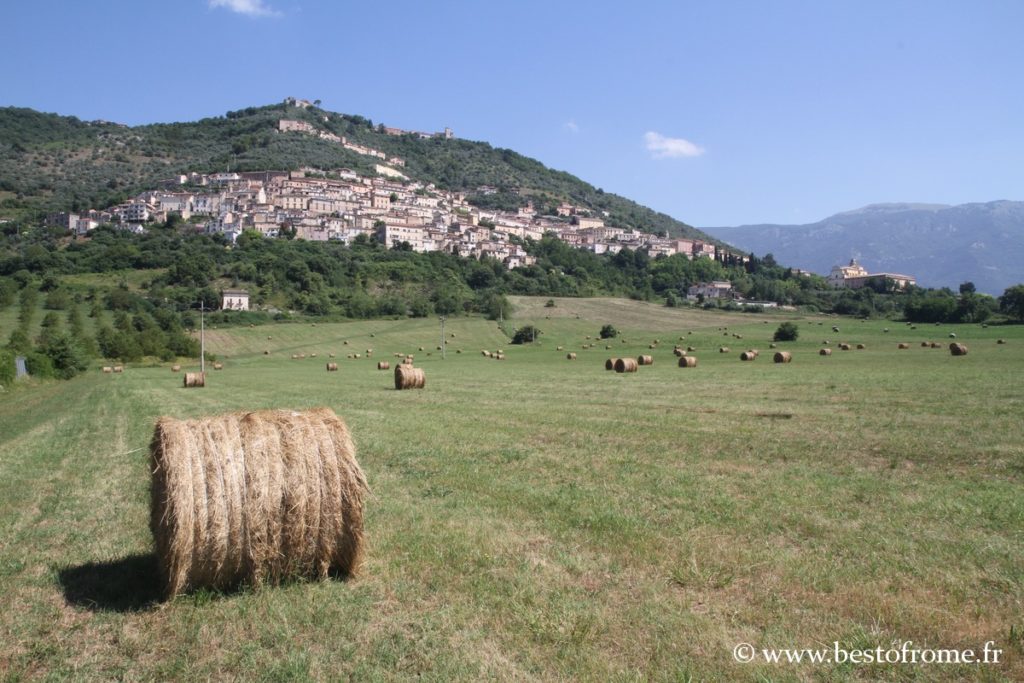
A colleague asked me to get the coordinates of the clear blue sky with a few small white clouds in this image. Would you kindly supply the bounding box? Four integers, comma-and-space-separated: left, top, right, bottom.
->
0, 0, 1024, 226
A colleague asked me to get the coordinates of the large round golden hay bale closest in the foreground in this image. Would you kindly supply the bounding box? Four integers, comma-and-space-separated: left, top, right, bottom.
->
150, 408, 368, 597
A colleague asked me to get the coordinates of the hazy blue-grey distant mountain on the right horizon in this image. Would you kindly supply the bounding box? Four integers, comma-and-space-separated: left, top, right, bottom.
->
703, 201, 1024, 295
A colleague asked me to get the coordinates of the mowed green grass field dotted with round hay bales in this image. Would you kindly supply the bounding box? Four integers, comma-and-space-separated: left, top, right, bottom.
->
0, 298, 1024, 681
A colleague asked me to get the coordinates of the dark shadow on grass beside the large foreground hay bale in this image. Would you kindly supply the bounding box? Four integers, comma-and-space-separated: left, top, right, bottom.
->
57, 553, 161, 612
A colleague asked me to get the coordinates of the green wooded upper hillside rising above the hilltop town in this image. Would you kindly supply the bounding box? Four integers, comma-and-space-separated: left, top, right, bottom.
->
0, 102, 714, 241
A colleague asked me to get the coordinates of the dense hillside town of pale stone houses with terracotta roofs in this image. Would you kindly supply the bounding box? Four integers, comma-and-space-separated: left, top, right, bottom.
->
47, 163, 742, 268
